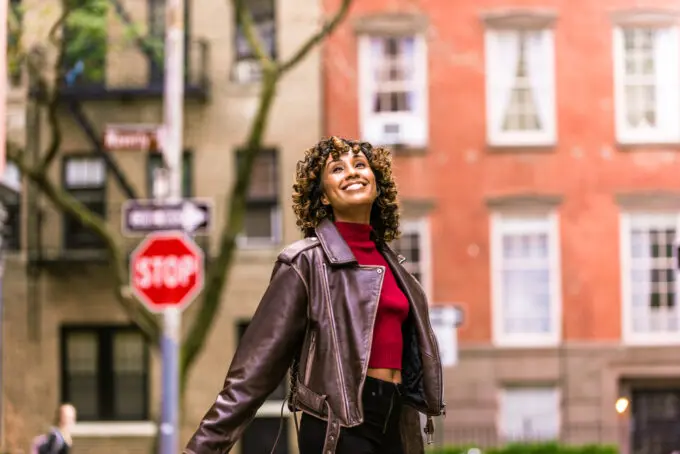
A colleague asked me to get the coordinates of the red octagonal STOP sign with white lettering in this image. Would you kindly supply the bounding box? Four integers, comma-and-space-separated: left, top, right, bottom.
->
130, 232, 205, 312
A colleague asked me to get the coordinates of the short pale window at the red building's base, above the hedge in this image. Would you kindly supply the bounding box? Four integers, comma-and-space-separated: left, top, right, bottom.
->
499, 387, 560, 441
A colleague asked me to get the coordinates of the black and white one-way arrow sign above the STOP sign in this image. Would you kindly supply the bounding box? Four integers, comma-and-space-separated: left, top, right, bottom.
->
122, 199, 213, 235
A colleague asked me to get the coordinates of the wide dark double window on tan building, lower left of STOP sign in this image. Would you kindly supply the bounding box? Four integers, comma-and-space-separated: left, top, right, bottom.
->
61, 326, 149, 421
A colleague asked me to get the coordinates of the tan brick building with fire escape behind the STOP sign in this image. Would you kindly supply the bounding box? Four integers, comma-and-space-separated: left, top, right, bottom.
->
2, 0, 321, 454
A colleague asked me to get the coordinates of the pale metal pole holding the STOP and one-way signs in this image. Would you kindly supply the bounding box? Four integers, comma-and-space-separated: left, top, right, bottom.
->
159, 0, 184, 454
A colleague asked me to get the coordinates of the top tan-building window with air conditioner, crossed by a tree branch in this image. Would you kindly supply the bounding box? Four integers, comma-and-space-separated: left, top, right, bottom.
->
232, 0, 276, 83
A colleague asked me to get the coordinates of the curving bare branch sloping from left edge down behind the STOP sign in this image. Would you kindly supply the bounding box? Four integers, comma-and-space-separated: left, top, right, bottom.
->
7, 142, 160, 345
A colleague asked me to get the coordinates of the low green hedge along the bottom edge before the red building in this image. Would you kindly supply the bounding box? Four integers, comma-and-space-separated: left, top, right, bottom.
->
426, 443, 618, 454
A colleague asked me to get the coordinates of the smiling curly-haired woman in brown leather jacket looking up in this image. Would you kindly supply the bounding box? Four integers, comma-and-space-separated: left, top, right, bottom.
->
184, 137, 444, 454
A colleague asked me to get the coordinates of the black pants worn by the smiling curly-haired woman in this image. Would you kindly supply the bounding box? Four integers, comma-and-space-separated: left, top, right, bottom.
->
299, 377, 404, 454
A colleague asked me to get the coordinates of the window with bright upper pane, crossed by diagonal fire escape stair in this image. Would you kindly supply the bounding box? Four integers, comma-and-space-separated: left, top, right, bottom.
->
63, 156, 106, 249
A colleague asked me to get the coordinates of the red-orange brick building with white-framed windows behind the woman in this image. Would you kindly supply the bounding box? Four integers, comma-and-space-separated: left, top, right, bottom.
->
323, 0, 680, 454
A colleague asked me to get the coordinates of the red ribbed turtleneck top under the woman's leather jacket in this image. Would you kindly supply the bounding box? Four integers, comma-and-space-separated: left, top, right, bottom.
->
335, 221, 409, 370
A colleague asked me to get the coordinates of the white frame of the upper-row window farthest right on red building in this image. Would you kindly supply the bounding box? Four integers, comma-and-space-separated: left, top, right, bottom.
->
613, 26, 680, 144
